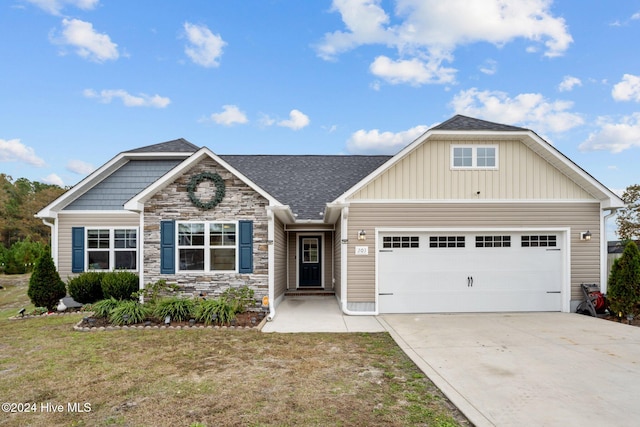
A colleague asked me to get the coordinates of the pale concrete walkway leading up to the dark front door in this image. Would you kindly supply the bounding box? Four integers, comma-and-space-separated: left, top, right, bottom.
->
262, 296, 386, 332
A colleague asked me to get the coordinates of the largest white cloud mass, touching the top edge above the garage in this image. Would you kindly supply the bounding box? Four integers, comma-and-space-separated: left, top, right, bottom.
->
315, 0, 573, 85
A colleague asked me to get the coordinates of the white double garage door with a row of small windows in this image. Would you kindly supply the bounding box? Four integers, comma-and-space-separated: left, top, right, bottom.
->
378, 231, 565, 313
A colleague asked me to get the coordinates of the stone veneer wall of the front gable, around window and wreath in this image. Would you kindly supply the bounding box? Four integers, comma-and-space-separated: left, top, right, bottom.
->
143, 157, 269, 300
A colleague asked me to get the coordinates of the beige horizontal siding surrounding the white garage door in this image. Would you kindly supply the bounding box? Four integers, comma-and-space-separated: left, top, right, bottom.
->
346, 202, 600, 303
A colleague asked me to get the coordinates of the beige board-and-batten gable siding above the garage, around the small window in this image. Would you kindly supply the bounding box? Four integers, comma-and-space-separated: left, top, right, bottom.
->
349, 140, 594, 200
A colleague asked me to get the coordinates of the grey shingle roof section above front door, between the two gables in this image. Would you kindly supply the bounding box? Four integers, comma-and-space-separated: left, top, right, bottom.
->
219, 155, 391, 220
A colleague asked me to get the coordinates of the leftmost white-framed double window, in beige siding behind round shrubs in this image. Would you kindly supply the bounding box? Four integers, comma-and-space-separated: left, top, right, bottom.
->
86, 228, 138, 270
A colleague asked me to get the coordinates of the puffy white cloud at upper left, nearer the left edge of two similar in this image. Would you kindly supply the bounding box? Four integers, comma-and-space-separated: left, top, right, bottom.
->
51, 18, 120, 62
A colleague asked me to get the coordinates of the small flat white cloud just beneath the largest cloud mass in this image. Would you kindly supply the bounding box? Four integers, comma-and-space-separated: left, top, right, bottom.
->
369, 55, 456, 86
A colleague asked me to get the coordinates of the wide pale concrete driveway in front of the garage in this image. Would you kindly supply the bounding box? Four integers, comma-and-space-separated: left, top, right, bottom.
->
378, 313, 640, 427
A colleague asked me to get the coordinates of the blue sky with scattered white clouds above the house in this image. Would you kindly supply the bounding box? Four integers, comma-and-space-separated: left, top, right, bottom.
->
0, 0, 640, 191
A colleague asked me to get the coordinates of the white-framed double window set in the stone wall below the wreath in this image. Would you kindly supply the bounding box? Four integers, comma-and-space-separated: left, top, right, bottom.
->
178, 222, 237, 271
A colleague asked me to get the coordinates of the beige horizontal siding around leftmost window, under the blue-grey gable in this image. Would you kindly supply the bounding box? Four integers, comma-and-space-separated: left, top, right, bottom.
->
58, 212, 141, 281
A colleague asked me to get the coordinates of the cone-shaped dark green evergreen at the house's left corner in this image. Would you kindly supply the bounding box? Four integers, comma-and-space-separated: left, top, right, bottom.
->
27, 253, 67, 311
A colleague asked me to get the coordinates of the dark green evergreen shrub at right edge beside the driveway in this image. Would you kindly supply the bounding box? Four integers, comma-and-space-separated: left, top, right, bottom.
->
607, 242, 640, 316
